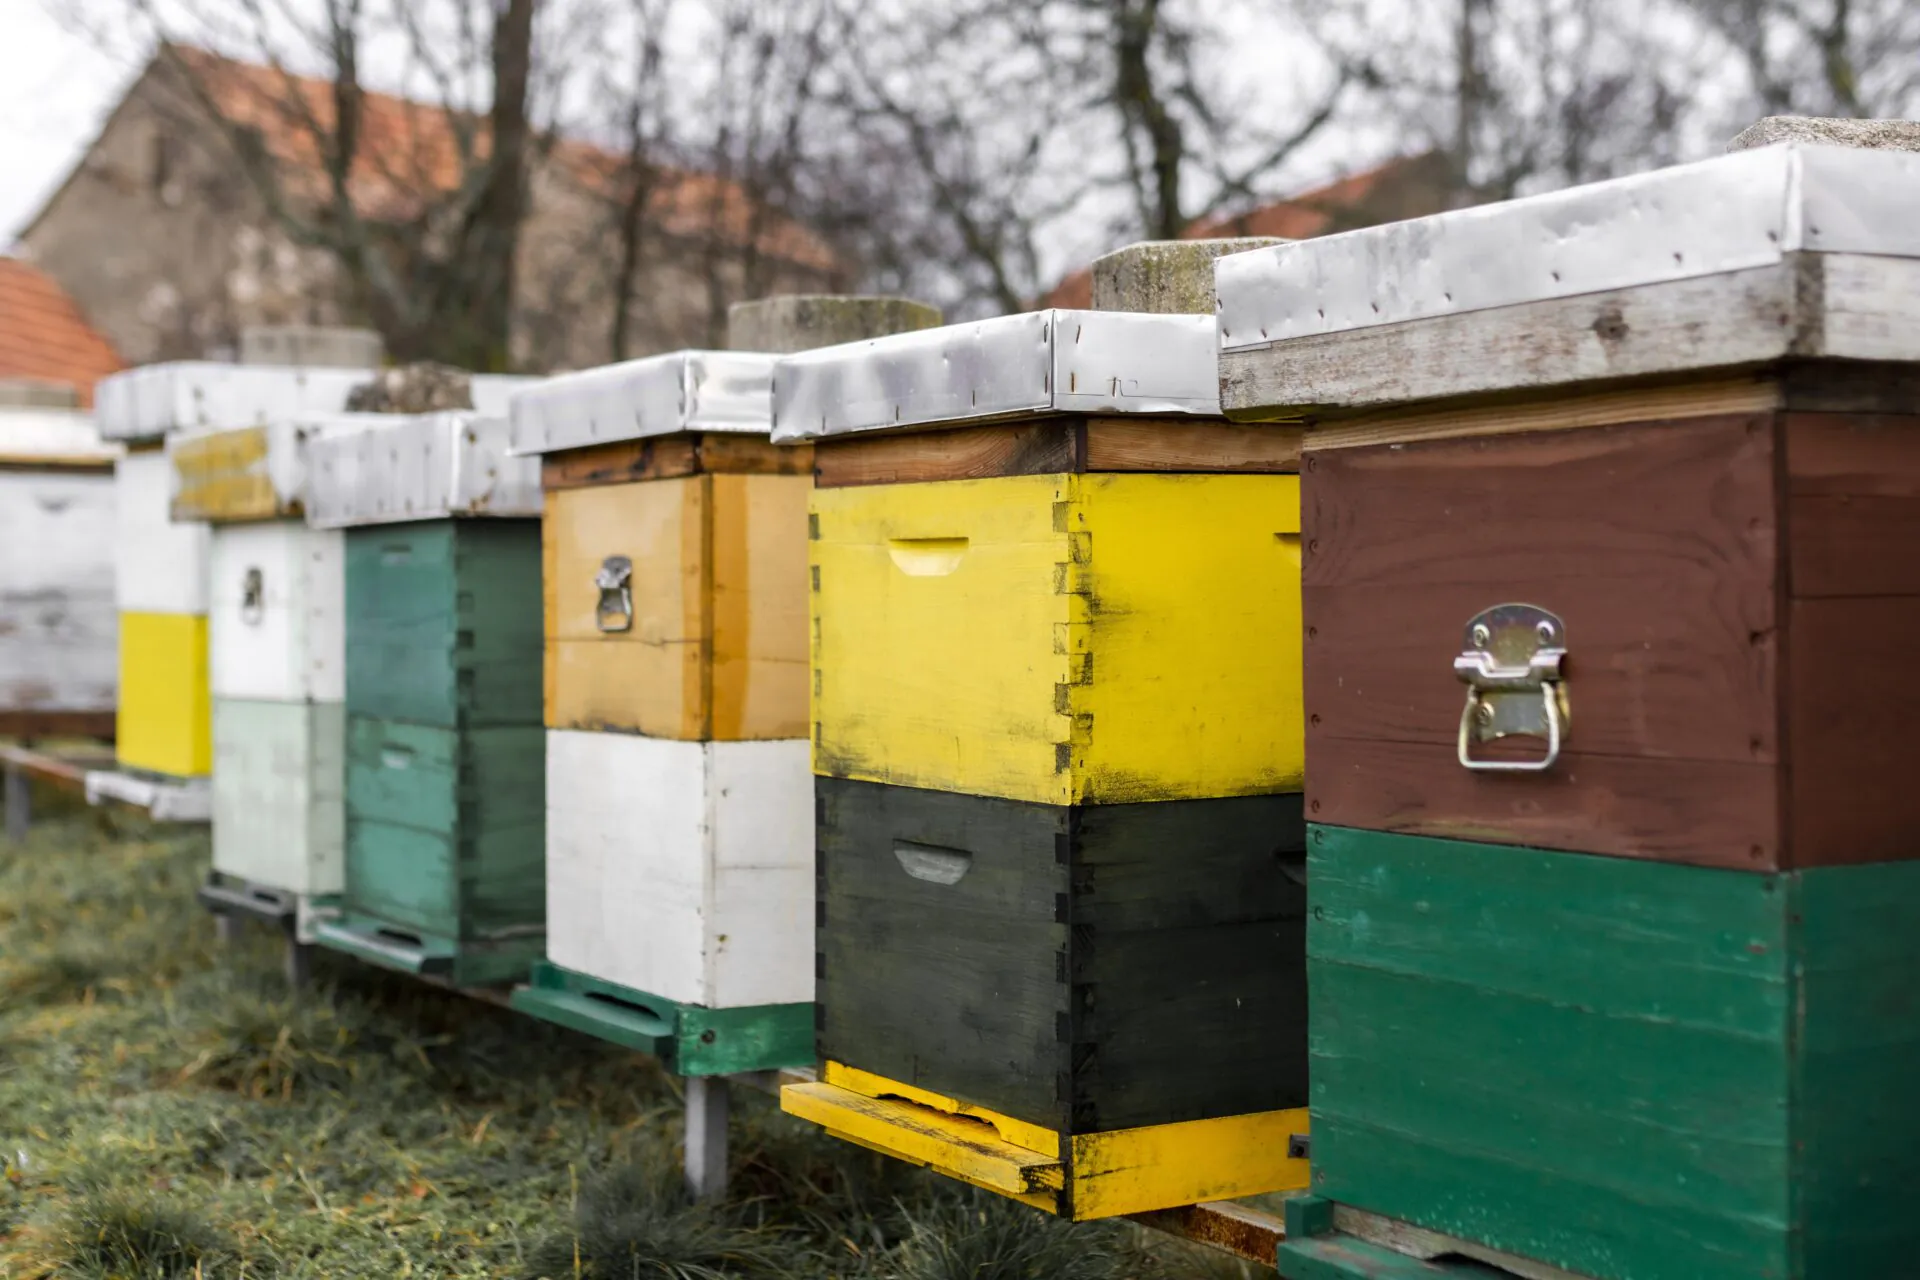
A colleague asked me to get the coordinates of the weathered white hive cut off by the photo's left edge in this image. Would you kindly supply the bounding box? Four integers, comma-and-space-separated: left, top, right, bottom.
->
0, 407, 119, 737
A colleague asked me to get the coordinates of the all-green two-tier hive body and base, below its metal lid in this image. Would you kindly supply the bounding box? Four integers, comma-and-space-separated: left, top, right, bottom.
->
321, 518, 545, 984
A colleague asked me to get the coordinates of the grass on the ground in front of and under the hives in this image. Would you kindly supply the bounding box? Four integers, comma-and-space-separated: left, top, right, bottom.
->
0, 794, 1228, 1280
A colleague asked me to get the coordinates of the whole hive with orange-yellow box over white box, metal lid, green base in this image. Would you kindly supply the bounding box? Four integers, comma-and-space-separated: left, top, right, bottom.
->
513, 351, 814, 1075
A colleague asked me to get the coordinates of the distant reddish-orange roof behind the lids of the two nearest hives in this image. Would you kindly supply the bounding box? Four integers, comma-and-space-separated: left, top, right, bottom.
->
1041, 152, 1459, 309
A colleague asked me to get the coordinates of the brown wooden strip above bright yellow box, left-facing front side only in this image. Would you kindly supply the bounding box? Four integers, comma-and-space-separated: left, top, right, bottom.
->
814, 416, 1081, 489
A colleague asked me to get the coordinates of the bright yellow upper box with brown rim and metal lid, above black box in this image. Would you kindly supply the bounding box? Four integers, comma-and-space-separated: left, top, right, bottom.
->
774, 311, 1304, 804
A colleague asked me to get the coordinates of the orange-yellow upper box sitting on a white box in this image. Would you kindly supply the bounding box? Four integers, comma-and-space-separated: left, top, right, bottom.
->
541, 474, 812, 741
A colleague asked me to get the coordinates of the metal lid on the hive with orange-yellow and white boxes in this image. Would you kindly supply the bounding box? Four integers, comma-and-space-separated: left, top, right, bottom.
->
509, 351, 774, 453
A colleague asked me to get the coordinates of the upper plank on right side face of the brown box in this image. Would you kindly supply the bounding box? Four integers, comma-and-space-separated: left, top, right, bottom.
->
1784, 413, 1920, 599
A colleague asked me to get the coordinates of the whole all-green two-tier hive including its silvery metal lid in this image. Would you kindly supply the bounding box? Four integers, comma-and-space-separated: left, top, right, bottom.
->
307, 413, 545, 984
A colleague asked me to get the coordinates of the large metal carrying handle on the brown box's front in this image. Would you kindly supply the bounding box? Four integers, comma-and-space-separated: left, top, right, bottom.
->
1453, 604, 1569, 773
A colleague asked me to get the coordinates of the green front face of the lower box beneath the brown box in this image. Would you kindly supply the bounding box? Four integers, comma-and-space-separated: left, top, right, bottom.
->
1308, 827, 1797, 1280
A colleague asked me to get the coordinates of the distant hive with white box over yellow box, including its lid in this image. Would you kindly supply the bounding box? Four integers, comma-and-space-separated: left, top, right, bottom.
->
96, 361, 378, 779
